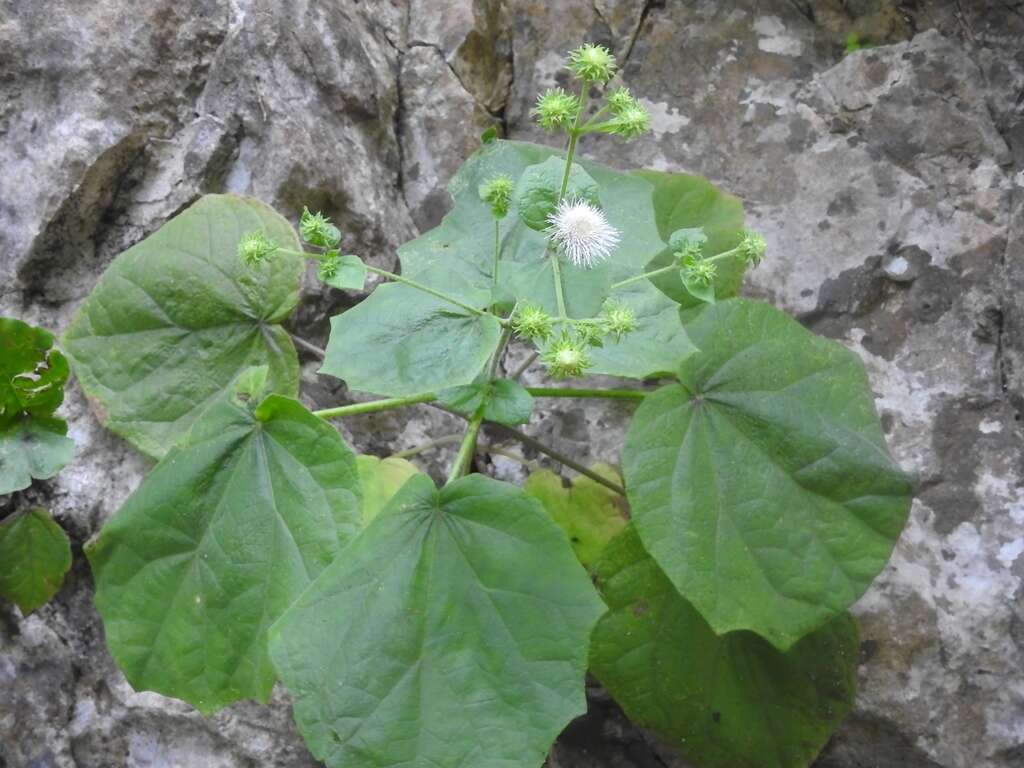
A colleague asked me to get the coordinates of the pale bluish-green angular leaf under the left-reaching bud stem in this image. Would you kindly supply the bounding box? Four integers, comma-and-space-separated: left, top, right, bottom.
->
321, 283, 502, 397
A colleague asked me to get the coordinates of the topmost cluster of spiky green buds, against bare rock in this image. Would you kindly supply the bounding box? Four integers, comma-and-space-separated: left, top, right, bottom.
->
532, 43, 650, 139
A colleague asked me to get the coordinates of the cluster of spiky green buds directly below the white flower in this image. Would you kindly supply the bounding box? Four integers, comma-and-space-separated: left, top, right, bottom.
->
512, 301, 637, 379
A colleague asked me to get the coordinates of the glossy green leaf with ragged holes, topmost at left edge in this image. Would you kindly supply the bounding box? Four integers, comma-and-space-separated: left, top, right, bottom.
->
0, 317, 68, 428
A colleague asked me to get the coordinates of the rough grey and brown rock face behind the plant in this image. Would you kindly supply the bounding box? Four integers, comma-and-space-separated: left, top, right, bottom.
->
0, 0, 1024, 768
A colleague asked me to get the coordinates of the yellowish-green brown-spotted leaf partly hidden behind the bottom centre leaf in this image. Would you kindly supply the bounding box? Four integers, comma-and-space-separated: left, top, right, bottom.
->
523, 464, 628, 567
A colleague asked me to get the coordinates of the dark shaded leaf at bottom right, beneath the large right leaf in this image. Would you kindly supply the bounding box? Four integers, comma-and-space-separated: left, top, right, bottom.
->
590, 529, 858, 768
